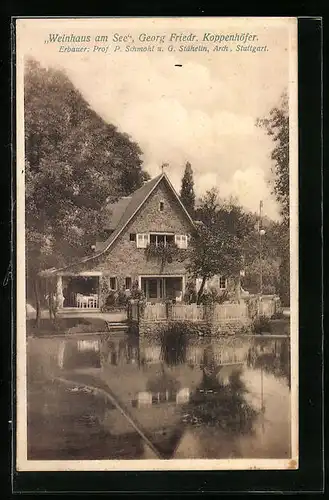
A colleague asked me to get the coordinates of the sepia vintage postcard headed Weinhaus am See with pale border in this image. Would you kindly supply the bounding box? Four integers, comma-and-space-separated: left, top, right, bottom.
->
15, 17, 298, 471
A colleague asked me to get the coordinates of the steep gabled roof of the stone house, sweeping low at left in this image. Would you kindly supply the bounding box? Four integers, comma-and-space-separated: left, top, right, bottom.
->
43, 173, 195, 275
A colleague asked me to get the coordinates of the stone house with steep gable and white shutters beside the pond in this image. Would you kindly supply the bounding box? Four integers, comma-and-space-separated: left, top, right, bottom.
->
43, 173, 220, 311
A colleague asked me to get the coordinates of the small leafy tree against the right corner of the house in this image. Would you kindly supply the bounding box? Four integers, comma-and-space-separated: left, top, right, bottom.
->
187, 189, 250, 303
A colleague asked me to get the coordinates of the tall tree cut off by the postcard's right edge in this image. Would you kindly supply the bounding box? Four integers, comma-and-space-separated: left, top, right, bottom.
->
257, 93, 290, 306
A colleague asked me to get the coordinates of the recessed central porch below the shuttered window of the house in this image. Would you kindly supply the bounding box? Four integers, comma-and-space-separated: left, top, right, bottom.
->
139, 275, 185, 304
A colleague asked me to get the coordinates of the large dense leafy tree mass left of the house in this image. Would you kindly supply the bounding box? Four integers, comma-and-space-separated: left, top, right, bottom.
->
24, 60, 147, 322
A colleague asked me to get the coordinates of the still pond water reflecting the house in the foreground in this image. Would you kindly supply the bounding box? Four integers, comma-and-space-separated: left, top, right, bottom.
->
27, 332, 291, 460
